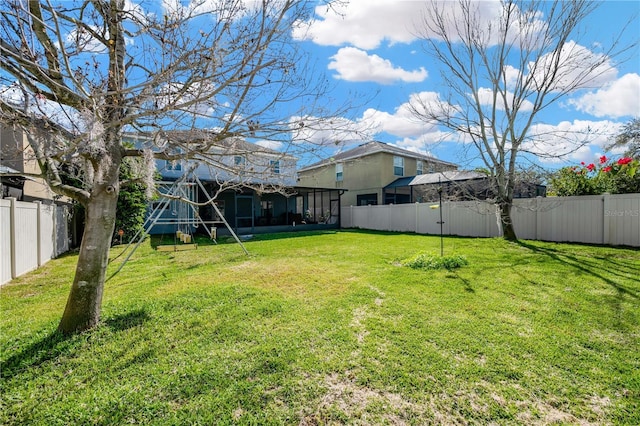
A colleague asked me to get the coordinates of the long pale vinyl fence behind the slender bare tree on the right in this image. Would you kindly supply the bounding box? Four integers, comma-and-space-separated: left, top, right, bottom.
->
341, 194, 640, 247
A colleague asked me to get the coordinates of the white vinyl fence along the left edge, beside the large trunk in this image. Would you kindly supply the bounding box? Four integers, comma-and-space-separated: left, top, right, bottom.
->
0, 198, 69, 285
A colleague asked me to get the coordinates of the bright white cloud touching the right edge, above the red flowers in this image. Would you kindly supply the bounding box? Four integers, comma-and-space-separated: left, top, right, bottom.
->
568, 74, 640, 118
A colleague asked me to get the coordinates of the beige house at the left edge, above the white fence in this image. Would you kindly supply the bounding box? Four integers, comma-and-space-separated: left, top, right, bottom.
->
0, 126, 55, 203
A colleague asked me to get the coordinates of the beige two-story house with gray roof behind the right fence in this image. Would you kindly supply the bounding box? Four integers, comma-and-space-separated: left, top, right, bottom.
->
298, 141, 458, 206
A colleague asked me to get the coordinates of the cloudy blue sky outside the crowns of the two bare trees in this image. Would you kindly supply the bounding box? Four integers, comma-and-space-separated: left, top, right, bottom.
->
0, 0, 640, 173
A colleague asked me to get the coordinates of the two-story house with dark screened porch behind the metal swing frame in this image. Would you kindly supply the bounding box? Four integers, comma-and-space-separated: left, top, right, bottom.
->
125, 132, 342, 234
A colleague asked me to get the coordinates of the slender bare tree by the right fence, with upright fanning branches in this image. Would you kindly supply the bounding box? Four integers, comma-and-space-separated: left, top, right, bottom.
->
412, 0, 630, 240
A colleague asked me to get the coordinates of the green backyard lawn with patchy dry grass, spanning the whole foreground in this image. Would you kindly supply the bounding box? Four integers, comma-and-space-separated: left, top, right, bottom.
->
0, 231, 640, 425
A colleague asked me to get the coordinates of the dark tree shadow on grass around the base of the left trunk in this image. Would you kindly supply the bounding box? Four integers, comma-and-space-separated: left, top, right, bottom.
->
0, 309, 150, 380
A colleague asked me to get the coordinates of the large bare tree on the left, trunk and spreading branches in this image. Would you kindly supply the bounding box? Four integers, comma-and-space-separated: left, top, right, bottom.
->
0, 0, 350, 333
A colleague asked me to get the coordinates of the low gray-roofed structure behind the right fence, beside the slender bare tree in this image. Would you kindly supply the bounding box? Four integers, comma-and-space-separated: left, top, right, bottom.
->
384, 170, 546, 204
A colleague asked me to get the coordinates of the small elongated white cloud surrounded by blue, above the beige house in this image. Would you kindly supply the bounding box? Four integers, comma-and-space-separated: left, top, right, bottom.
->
329, 47, 427, 84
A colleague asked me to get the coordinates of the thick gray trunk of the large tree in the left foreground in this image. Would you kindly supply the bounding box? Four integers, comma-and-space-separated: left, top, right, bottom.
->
58, 185, 118, 334
